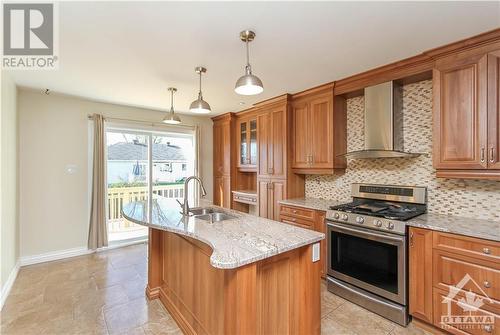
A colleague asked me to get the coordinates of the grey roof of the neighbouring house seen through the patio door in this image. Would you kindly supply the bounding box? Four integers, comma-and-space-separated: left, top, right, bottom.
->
108, 142, 186, 161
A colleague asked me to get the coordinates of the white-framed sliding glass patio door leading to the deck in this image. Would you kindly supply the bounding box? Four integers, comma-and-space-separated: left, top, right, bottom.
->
106, 127, 196, 243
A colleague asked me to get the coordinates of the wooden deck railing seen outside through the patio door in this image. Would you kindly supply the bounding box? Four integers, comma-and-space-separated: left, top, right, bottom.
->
108, 184, 184, 231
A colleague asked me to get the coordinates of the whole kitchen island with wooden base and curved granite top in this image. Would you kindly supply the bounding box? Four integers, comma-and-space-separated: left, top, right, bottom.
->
122, 198, 324, 335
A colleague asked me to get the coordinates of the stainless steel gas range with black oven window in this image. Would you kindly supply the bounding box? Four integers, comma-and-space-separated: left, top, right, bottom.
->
326, 184, 427, 325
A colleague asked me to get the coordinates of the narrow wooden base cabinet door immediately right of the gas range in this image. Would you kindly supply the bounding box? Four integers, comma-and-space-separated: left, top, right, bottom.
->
408, 227, 432, 323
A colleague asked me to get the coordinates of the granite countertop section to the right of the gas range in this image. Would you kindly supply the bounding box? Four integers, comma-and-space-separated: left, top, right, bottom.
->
406, 213, 500, 242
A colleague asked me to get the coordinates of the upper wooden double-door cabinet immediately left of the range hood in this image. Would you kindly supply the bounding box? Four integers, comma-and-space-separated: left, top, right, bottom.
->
291, 88, 346, 174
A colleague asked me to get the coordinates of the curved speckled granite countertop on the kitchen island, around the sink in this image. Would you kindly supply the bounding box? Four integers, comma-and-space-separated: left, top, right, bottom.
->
122, 198, 325, 269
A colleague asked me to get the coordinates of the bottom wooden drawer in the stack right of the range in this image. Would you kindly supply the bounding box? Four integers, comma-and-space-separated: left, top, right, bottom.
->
433, 288, 500, 335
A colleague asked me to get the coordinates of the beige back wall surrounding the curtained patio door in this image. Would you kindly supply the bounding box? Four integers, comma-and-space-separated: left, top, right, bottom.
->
18, 89, 213, 257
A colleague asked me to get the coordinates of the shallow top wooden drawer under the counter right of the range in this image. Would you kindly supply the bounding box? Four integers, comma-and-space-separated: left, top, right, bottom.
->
433, 232, 500, 262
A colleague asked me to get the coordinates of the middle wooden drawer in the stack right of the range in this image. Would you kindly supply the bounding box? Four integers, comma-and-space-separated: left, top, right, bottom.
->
433, 250, 500, 300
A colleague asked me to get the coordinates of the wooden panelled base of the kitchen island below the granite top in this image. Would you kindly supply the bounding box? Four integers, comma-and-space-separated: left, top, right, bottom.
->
147, 229, 321, 335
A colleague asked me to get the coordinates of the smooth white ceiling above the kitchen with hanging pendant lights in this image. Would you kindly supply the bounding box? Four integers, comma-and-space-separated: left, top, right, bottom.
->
4, 1, 500, 115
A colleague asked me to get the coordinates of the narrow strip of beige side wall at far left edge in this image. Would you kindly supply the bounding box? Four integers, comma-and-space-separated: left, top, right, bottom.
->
0, 71, 19, 290
